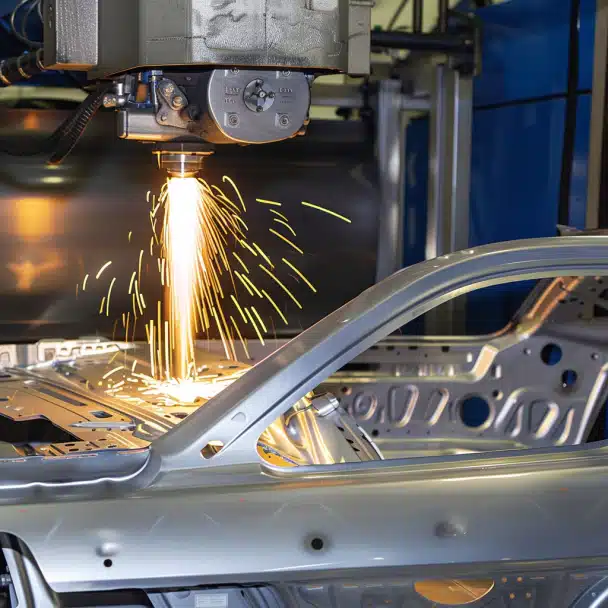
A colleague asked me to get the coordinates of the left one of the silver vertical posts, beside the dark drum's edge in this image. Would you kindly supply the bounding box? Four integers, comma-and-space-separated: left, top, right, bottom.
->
376, 80, 405, 281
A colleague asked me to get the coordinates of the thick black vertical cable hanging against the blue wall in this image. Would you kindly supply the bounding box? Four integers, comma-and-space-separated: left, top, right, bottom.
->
557, 0, 581, 226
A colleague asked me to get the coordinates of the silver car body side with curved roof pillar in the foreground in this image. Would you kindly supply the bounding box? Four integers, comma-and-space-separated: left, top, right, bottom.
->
0, 236, 608, 591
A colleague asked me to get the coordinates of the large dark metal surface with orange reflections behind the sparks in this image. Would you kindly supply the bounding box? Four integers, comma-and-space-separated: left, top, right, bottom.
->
0, 110, 377, 343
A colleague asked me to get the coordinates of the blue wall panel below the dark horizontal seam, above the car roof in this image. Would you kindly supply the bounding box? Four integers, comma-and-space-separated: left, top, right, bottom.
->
470, 99, 565, 246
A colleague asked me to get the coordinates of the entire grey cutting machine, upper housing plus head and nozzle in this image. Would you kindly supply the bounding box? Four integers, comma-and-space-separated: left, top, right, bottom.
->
44, 0, 372, 174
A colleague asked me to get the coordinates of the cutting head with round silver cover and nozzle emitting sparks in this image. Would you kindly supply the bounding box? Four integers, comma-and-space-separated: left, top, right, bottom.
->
112, 68, 312, 175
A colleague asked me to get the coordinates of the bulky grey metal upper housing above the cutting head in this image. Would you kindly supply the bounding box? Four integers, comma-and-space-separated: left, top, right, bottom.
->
54, 0, 372, 76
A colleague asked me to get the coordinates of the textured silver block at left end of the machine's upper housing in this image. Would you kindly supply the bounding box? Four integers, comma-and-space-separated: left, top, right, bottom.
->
43, 0, 99, 70
